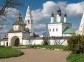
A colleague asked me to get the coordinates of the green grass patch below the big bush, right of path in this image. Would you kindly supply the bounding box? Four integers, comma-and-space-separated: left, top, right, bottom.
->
67, 53, 84, 62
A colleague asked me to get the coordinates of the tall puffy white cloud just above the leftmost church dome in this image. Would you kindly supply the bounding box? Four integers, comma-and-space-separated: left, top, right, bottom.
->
42, 1, 56, 16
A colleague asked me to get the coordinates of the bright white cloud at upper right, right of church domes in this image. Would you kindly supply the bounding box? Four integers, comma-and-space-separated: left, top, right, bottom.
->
66, 2, 84, 16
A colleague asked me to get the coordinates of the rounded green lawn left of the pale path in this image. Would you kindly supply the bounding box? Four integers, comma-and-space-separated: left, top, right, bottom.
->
0, 47, 23, 59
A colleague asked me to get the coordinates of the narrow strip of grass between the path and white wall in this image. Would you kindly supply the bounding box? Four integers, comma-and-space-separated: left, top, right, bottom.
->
28, 45, 68, 50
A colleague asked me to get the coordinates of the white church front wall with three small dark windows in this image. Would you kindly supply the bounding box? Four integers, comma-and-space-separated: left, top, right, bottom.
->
48, 23, 62, 37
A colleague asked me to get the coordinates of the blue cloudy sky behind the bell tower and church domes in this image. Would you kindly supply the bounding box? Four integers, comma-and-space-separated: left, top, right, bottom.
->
0, 0, 84, 33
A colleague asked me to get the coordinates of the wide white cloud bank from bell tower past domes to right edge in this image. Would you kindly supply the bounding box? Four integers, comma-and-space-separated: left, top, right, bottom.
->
32, 1, 84, 23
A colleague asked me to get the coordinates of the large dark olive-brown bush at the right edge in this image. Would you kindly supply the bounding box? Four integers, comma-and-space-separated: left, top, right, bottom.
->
68, 35, 84, 54
